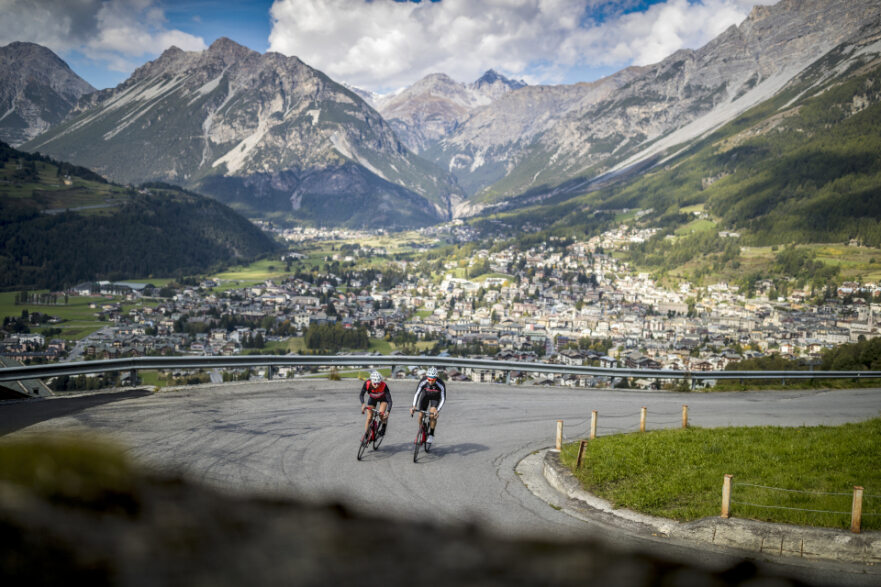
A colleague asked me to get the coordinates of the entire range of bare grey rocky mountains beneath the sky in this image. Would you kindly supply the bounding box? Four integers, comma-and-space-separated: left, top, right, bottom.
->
0, 0, 881, 234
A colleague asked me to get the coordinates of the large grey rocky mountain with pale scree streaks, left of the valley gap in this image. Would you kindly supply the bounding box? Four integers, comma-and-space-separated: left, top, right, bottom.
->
21, 38, 461, 228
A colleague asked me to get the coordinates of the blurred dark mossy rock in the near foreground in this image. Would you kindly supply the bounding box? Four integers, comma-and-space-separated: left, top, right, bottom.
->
0, 440, 799, 586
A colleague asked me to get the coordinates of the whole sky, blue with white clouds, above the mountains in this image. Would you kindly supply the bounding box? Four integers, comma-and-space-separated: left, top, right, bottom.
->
0, 0, 776, 92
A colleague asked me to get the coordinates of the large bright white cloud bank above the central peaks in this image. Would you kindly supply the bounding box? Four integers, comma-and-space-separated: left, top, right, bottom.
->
269, 0, 768, 90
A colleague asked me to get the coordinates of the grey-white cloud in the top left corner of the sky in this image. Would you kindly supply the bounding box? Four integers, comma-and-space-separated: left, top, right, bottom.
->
0, 0, 207, 71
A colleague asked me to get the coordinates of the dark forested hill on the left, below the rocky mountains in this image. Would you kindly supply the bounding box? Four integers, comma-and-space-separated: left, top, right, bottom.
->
0, 144, 276, 290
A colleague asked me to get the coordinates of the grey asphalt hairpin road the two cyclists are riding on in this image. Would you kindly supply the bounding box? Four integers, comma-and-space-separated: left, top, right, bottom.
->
0, 379, 881, 585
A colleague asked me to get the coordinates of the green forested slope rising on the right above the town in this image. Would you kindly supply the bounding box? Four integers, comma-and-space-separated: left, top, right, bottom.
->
460, 49, 881, 288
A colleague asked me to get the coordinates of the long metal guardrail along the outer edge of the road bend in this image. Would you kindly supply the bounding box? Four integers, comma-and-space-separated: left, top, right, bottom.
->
0, 355, 881, 386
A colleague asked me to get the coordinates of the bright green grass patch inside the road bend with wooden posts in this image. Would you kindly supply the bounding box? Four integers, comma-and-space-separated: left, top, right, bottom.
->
561, 418, 881, 530
